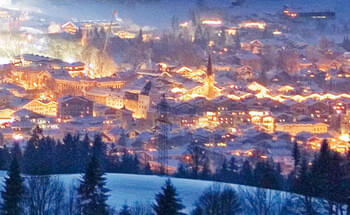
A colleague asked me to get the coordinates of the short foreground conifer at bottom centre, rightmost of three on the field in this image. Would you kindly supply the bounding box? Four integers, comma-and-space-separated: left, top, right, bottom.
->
153, 179, 184, 215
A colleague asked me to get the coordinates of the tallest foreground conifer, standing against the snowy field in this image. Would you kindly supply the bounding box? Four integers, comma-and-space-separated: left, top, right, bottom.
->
78, 156, 109, 215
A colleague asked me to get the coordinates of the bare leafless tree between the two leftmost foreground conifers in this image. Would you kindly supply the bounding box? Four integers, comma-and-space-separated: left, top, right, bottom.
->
26, 176, 65, 215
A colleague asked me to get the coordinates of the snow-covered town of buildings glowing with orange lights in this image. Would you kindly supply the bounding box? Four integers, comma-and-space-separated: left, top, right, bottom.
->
0, 1, 350, 175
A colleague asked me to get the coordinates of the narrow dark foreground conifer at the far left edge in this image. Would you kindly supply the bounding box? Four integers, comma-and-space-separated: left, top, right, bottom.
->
1, 158, 24, 215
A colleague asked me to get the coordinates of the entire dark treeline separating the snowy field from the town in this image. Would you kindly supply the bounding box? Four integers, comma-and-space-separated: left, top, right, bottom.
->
0, 128, 350, 214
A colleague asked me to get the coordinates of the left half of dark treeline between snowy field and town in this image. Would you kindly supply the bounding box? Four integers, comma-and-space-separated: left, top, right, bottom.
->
4, 128, 144, 175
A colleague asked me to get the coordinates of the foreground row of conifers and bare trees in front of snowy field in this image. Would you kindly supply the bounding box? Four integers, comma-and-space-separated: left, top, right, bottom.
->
0, 151, 241, 215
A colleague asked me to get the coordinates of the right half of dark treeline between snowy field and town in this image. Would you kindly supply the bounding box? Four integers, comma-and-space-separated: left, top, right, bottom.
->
176, 140, 350, 214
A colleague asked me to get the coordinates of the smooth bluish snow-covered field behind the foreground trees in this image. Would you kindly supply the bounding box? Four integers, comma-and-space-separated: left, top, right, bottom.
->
0, 171, 258, 212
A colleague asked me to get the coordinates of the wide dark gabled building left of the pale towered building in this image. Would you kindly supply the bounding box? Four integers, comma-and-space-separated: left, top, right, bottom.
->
57, 96, 94, 120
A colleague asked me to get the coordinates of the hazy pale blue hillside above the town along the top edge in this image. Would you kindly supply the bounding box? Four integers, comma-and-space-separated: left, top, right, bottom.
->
9, 0, 350, 28
